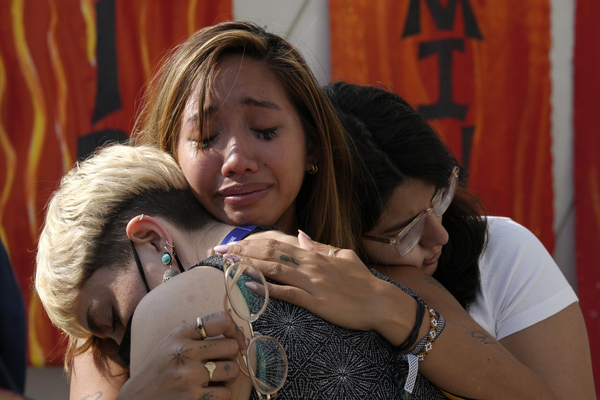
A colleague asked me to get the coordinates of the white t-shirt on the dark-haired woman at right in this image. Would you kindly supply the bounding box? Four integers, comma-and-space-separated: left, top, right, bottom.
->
469, 217, 577, 340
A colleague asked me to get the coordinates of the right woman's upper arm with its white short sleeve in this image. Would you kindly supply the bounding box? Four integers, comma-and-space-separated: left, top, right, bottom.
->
480, 217, 596, 399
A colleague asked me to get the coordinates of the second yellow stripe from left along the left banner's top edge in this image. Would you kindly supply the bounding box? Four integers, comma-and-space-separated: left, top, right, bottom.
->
48, 0, 72, 174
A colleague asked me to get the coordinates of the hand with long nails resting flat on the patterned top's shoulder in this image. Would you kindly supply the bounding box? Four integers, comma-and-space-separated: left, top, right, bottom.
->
215, 234, 416, 343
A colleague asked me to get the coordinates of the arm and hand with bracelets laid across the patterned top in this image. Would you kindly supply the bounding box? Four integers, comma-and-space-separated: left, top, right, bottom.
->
219, 234, 554, 399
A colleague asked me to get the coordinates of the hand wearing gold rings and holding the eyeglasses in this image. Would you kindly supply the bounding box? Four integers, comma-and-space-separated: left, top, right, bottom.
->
117, 312, 246, 399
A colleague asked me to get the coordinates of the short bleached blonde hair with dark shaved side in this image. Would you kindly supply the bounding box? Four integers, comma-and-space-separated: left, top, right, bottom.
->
35, 145, 212, 339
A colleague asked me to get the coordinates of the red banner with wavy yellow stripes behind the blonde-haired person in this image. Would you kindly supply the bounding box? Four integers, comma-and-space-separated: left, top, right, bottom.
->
0, 0, 232, 366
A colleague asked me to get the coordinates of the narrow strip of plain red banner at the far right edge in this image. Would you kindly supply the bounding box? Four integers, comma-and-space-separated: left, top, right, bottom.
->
574, 0, 600, 394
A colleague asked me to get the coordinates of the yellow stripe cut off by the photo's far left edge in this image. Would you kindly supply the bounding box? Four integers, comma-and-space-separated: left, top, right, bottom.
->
0, 53, 17, 256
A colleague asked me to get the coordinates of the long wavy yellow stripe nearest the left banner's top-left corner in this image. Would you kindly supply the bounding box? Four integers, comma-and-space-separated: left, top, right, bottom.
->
11, 0, 46, 242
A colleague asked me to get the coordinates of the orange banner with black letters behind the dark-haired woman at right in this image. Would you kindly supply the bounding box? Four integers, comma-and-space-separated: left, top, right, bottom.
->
329, 0, 554, 252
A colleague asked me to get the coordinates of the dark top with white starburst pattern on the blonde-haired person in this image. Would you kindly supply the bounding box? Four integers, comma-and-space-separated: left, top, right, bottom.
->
196, 256, 446, 400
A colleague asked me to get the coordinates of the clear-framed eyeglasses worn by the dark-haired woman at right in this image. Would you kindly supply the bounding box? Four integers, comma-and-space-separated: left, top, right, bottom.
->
363, 167, 460, 256
